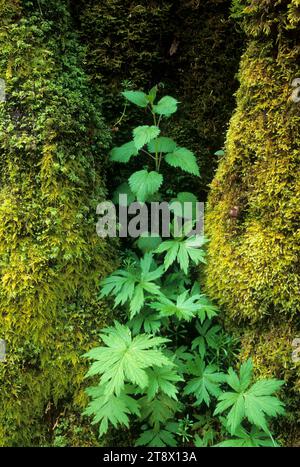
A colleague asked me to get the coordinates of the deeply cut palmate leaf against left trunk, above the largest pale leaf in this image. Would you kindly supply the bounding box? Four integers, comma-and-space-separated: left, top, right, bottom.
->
100, 253, 164, 318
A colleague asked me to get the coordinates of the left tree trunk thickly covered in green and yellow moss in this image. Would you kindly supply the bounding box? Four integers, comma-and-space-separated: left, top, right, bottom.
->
0, 0, 111, 446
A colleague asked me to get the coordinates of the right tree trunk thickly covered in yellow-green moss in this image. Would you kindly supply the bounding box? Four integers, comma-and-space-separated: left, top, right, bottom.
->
206, 0, 300, 446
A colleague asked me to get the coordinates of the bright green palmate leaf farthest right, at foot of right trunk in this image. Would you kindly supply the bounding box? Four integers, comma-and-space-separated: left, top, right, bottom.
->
214, 359, 284, 434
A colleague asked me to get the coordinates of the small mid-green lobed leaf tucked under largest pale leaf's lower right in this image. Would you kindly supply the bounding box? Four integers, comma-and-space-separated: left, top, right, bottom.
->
147, 365, 183, 400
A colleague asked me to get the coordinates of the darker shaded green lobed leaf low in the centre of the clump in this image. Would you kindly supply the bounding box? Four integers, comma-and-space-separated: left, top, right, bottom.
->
139, 393, 182, 430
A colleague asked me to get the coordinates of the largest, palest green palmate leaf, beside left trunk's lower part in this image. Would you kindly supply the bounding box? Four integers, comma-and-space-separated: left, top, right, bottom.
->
84, 321, 173, 398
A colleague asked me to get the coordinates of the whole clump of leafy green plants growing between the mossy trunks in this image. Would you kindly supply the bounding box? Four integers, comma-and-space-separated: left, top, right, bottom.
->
85, 87, 284, 447
